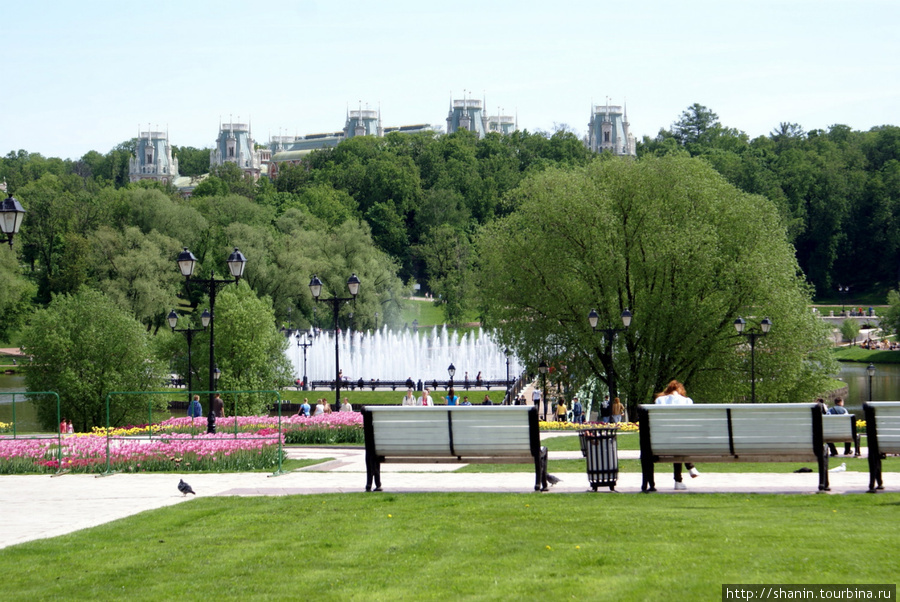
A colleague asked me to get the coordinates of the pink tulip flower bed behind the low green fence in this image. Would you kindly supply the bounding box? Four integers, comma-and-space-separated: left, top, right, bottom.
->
0, 432, 279, 474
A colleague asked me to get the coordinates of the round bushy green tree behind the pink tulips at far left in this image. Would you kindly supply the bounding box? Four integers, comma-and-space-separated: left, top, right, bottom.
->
21, 288, 165, 431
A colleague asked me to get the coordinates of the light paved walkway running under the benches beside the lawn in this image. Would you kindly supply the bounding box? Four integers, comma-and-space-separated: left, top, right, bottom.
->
0, 440, 884, 548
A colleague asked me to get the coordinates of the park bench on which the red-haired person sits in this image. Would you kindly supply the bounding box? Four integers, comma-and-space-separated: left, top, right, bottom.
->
638, 403, 829, 491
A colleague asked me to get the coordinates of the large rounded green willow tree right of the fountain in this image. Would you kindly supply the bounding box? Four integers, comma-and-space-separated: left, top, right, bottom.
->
477, 157, 834, 414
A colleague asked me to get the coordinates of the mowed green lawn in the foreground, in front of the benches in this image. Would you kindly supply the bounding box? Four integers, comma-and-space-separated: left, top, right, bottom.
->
0, 493, 900, 601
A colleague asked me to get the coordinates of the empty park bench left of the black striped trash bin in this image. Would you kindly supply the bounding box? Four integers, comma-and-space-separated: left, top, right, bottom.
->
362, 406, 547, 491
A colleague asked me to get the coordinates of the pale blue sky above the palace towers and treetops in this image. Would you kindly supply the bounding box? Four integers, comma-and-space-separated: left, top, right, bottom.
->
0, 0, 900, 159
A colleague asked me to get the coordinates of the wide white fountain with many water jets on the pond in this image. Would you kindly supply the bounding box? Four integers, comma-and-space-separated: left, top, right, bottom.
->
285, 326, 523, 384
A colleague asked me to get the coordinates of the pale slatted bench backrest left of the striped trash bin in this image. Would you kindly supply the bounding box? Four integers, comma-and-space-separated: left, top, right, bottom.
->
365, 406, 540, 457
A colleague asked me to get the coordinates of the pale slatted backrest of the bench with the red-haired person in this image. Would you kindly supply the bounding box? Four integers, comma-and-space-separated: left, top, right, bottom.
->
641, 403, 815, 455
